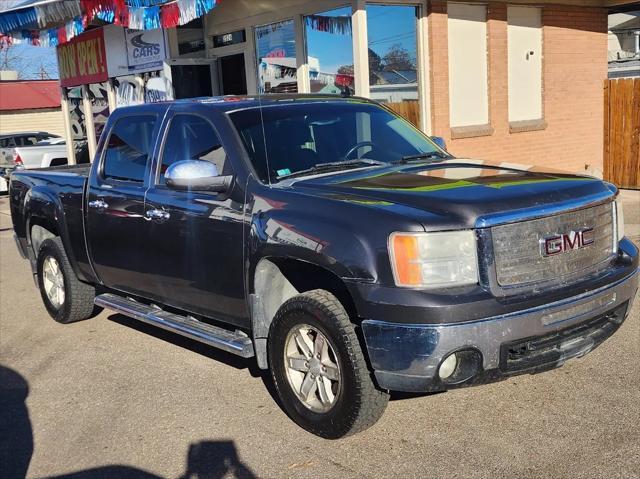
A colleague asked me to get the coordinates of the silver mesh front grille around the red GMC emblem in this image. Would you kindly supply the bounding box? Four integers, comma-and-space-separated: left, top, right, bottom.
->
491, 203, 615, 287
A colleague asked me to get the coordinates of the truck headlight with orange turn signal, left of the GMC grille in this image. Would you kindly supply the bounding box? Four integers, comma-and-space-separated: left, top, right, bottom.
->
389, 230, 478, 288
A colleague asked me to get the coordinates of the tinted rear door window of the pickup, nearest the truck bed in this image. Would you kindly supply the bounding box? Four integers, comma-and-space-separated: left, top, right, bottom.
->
102, 115, 156, 182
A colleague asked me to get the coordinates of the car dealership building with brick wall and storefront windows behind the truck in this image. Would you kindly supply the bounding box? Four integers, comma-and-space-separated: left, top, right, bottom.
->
0, 0, 633, 174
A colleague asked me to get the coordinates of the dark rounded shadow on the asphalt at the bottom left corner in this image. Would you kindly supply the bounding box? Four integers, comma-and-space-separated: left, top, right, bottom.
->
0, 365, 33, 479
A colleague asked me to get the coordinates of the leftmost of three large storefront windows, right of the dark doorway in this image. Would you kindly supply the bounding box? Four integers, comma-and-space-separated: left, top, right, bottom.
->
255, 20, 298, 93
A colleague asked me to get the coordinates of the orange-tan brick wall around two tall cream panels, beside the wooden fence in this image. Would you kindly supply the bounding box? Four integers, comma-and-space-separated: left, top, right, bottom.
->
429, 0, 607, 174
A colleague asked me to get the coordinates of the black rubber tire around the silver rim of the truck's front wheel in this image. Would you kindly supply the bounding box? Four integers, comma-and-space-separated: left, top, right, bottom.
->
268, 290, 389, 439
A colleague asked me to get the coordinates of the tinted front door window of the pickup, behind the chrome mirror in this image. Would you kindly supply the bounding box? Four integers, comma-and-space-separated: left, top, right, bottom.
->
158, 115, 228, 184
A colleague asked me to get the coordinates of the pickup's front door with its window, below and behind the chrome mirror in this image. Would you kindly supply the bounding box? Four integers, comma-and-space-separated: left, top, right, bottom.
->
145, 105, 248, 326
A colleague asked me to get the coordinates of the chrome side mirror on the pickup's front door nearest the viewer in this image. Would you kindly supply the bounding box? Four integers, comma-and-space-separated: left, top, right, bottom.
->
164, 160, 233, 193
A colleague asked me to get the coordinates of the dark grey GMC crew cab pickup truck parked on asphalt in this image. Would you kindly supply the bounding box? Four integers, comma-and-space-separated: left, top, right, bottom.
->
10, 95, 638, 438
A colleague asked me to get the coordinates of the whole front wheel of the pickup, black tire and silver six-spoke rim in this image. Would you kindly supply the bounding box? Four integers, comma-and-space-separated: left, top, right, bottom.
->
268, 290, 389, 439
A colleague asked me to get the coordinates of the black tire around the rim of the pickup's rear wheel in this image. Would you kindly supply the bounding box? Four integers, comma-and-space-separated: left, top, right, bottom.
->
37, 238, 100, 324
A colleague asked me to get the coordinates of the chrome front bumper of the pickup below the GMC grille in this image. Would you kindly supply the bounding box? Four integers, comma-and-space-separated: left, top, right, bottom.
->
362, 269, 640, 392
